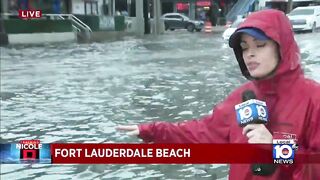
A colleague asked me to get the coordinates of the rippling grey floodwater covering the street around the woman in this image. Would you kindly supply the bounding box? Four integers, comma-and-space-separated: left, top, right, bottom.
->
0, 31, 320, 179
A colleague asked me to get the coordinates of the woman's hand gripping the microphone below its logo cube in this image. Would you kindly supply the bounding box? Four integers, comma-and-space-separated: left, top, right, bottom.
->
242, 124, 272, 144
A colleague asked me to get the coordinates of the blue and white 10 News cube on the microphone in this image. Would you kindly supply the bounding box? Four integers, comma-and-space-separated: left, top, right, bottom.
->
235, 99, 268, 126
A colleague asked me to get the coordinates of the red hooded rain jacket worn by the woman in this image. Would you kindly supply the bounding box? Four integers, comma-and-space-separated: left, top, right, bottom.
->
139, 10, 320, 180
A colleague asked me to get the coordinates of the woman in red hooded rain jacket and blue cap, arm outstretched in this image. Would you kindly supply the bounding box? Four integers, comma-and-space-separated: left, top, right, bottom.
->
118, 10, 320, 180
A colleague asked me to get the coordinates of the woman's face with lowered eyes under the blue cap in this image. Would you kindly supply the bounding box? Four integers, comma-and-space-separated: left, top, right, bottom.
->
240, 34, 279, 78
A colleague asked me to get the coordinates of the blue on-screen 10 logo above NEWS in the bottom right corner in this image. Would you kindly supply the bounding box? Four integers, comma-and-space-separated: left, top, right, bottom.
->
273, 143, 296, 164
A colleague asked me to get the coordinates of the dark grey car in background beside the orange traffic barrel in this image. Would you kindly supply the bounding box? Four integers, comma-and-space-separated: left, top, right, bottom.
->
162, 13, 204, 32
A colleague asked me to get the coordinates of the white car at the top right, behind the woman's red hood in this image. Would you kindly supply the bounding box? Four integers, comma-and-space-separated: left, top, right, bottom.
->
287, 6, 320, 32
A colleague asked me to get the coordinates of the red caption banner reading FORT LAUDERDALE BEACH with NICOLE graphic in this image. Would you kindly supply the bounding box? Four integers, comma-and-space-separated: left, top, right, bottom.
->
1, 143, 320, 164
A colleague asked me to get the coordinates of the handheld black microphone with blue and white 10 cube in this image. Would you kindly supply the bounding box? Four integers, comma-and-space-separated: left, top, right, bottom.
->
235, 90, 276, 176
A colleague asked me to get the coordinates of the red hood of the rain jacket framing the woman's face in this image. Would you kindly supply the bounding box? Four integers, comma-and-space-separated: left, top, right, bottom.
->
230, 9, 302, 94
